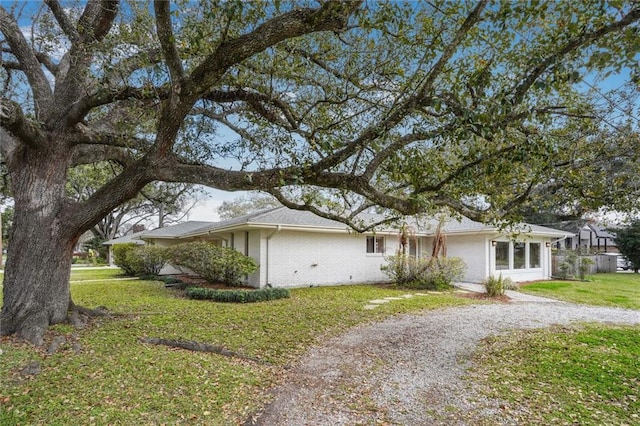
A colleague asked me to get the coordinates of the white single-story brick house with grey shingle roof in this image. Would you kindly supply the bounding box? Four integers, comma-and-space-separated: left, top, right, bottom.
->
105, 207, 570, 287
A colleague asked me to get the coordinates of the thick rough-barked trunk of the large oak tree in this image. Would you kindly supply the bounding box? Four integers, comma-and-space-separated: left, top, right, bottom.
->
0, 146, 79, 345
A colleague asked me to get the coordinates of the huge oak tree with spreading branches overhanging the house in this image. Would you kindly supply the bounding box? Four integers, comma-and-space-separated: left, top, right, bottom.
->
0, 0, 640, 343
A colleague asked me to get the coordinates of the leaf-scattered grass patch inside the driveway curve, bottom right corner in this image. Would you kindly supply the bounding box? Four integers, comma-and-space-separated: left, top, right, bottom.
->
471, 324, 640, 425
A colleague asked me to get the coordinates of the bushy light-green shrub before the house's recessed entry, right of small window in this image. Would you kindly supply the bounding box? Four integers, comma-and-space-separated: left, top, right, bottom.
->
383, 255, 467, 290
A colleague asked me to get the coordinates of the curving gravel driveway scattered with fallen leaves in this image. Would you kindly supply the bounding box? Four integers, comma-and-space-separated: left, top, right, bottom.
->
247, 295, 640, 426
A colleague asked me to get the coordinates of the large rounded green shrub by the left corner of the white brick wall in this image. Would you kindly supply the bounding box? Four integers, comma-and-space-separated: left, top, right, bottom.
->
170, 241, 258, 286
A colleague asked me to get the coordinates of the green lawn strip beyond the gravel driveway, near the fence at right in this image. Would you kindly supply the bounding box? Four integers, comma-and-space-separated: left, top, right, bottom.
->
520, 274, 640, 309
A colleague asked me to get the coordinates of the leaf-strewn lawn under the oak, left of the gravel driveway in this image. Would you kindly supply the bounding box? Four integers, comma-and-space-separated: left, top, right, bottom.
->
0, 278, 472, 425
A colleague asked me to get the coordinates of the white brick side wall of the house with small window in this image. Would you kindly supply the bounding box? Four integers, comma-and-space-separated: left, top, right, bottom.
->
260, 230, 398, 287
